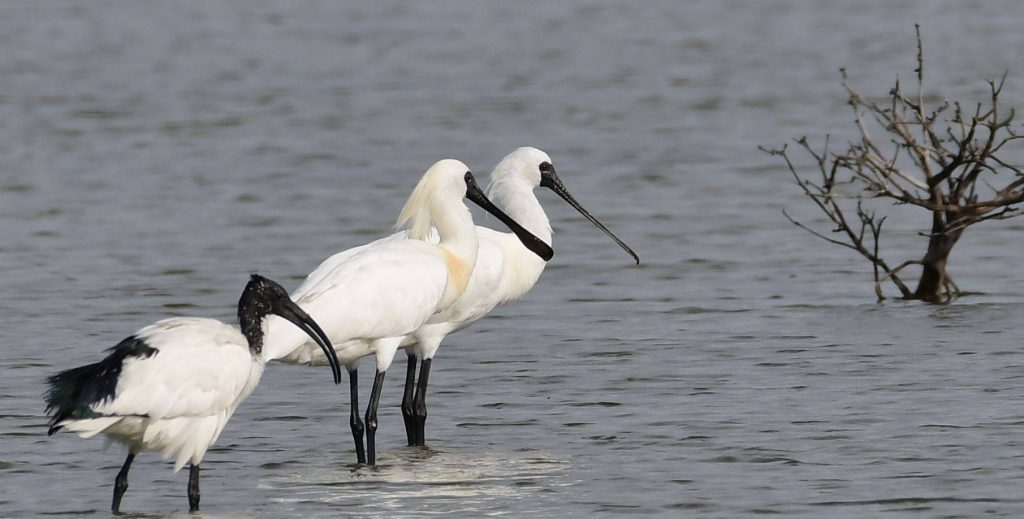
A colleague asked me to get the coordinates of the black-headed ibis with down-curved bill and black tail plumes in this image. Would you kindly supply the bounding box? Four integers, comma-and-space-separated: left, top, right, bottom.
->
46, 274, 341, 514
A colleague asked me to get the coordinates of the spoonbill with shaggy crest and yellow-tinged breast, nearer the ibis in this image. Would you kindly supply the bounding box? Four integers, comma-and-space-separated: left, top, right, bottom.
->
266, 160, 554, 465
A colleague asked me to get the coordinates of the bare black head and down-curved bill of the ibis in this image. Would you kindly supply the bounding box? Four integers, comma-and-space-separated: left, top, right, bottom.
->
239, 274, 341, 384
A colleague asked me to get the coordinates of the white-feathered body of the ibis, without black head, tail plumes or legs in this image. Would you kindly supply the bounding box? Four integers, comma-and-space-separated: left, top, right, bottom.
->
56, 317, 264, 472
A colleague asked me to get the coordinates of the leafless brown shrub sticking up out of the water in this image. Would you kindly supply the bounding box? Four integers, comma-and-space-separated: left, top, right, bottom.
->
761, 28, 1024, 303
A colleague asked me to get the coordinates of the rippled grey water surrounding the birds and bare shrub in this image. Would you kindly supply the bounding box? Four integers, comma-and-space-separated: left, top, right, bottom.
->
0, 1, 1024, 517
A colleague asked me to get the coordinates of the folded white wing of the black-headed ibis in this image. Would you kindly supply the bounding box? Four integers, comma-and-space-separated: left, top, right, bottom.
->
91, 317, 261, 419
